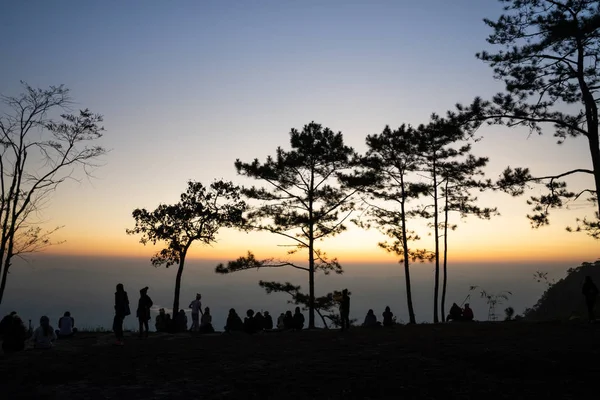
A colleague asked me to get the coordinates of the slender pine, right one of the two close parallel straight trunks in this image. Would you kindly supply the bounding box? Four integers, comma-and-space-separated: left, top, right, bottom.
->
440, 153, 498, 321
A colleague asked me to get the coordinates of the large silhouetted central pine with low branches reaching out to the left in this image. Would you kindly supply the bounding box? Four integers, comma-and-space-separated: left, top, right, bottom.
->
216, 122, 356, 328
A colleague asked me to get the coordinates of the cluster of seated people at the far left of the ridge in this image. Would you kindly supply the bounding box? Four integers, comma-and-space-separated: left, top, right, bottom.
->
0, 311, 77, 353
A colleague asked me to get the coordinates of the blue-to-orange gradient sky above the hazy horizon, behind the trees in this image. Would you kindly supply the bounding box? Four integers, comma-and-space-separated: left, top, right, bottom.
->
0, 0, 598, 262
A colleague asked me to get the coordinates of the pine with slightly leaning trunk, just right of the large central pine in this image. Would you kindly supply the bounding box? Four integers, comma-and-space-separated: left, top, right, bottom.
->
359, 125, 434, 324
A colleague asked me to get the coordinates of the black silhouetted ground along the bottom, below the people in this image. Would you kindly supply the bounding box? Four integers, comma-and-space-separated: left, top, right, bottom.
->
0, 322, 600, 400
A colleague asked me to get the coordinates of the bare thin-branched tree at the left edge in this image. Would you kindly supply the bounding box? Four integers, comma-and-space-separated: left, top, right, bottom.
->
0, 82, 106, 303
